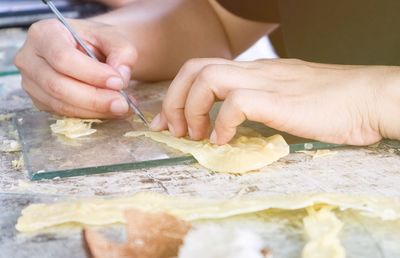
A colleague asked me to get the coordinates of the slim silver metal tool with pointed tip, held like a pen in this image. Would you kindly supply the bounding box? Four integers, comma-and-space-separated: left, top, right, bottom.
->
42, 0, 149, 127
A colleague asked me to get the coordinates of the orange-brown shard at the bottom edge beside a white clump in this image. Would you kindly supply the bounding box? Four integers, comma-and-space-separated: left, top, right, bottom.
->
84, 209, 190, 258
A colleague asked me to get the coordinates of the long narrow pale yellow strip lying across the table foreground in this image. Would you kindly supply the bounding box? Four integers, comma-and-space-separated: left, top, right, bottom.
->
16, 192, 400, 232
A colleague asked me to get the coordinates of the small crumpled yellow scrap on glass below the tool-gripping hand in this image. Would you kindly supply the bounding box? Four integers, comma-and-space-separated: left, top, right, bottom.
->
50, 118, 102, 139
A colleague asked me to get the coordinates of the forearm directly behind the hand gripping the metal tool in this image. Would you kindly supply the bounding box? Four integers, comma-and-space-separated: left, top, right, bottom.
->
92, 0, 232, 80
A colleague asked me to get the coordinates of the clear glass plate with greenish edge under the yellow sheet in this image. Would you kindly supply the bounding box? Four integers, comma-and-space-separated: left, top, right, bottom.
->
14, 100, 336, 180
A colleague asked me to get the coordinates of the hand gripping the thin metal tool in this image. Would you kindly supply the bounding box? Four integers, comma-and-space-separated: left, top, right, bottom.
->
15, 20, 136, 118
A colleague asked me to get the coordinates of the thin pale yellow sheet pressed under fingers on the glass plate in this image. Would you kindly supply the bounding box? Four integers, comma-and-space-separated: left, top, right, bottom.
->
125, 128, 289, 174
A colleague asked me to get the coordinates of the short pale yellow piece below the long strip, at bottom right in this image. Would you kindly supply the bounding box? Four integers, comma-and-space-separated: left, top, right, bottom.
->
302, 207, 346, 258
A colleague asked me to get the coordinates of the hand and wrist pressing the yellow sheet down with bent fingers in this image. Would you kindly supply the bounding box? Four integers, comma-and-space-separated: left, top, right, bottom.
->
151, 59, 398, 145
